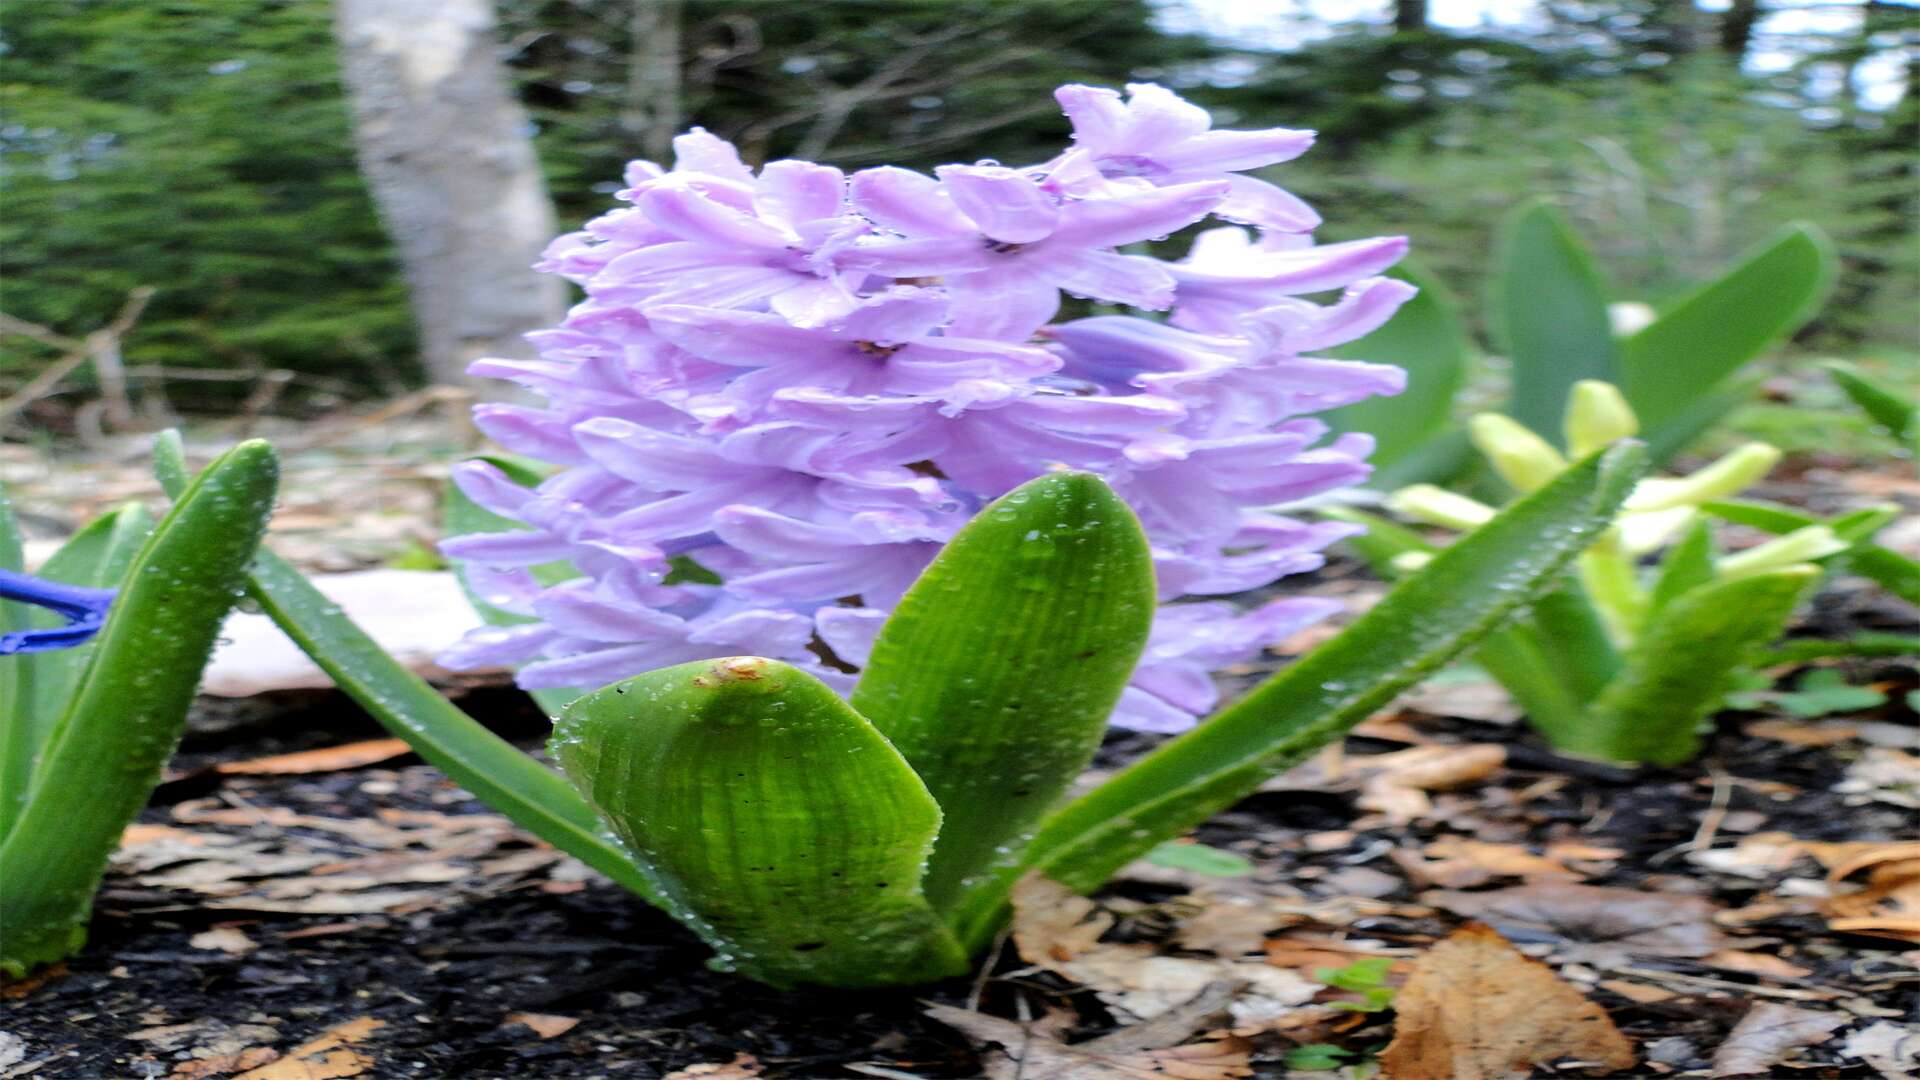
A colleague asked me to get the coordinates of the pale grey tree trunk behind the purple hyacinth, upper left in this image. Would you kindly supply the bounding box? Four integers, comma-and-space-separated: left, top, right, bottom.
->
334, 0, 566, 382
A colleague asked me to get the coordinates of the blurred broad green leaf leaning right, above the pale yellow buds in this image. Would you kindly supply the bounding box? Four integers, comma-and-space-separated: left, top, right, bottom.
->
1619, 225, 1836, 432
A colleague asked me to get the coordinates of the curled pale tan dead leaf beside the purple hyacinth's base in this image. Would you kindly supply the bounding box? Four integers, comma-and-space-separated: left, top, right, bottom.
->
1012, 872, 1321, 1028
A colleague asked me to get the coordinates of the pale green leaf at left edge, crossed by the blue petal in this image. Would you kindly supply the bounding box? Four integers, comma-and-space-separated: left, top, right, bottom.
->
0, 503, 154, 838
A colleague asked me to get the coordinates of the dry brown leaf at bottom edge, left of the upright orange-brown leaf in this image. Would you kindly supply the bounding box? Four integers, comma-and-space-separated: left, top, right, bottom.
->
927, 1005, 1254, 1080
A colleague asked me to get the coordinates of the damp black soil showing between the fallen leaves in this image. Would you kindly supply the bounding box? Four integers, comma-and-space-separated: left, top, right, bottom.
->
0, 641, 1920, 1080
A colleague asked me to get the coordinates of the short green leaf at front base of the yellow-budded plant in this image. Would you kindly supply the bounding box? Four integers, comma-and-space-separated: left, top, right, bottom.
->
1557, 565, 1820, 765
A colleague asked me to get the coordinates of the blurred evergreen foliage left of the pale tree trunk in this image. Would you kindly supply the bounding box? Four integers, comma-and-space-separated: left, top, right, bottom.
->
0, 0, 415, 392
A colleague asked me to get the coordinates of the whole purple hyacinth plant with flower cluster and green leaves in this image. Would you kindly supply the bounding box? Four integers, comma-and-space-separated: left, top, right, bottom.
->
159, 86, 1644, 986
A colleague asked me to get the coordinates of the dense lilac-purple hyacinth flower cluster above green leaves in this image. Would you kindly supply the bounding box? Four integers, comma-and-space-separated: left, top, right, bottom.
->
444, 85, 1413, 730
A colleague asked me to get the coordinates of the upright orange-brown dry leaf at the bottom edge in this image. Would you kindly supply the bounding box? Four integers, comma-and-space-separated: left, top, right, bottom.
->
1380, 924, 1634, 1080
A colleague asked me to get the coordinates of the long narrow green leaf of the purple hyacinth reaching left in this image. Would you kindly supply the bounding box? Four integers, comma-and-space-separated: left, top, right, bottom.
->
154, 432, 659, 899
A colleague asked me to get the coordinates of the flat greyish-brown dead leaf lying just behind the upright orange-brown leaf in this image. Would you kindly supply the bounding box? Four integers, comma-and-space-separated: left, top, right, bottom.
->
1421, 882, 1732, 967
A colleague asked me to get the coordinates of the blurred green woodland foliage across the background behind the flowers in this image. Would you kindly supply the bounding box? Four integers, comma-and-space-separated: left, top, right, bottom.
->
0, 0, 1920, 394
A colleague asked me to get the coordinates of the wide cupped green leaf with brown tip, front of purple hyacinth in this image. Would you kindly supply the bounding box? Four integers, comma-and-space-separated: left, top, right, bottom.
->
551, 657, 966, 986
